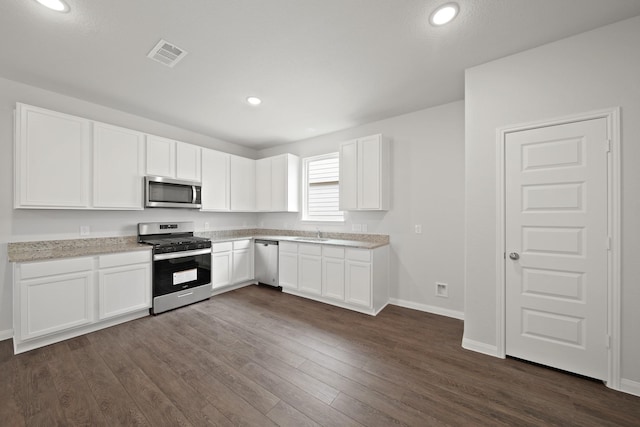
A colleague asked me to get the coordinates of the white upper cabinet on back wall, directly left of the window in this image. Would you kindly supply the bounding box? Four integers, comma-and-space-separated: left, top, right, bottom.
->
256, 154, 300, 212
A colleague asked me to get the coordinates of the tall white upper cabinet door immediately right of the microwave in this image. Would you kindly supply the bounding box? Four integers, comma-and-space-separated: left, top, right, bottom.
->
202, 148, 231, 211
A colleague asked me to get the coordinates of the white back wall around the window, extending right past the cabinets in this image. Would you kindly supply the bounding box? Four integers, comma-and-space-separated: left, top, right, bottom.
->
259, 101, 464, 317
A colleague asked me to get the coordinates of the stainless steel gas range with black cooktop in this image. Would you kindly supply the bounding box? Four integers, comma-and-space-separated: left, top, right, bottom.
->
138, 222, 211, 314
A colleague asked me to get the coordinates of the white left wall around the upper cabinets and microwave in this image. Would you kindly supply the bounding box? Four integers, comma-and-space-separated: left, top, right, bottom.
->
0, 78, 257, 339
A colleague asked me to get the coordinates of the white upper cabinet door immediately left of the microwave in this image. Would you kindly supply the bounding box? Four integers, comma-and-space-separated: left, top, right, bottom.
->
93, 123, 144, 209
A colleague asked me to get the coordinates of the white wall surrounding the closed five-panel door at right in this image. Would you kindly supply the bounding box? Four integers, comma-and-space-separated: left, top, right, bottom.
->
464, 18, 640, 390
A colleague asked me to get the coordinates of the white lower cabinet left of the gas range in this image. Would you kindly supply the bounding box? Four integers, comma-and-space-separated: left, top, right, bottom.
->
13, 251, 151, 354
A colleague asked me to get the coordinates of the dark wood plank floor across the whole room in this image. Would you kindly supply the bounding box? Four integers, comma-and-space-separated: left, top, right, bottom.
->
0, 286, 640, 427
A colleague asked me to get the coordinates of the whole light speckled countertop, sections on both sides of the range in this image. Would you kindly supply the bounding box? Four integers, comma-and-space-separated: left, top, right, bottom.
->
8, 229, 389, 262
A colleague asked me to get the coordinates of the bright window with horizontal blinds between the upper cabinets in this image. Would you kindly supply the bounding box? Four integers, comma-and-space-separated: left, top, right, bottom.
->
302, 153, 344, 221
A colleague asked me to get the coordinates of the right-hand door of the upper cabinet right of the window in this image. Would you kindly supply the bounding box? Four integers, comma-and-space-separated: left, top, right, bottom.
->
357, 135, 382, 209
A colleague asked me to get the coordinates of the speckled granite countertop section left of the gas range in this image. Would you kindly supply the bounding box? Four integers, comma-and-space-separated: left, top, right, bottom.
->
8, 236, 151, 262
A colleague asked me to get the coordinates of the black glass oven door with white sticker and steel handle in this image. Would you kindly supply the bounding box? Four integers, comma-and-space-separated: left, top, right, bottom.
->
153, 248, 211, 297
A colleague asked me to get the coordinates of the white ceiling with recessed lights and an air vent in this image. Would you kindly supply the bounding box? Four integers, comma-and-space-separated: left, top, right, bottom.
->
0, 0, 640, 149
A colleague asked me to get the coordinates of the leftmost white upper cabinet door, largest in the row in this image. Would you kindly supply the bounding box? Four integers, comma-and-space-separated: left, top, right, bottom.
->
14, 104, 91, 208
